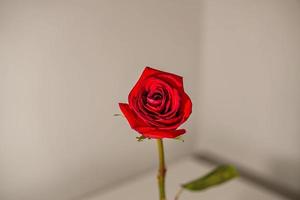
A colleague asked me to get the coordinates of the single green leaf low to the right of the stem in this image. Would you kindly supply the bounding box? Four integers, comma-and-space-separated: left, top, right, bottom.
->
182, 165, 239, 191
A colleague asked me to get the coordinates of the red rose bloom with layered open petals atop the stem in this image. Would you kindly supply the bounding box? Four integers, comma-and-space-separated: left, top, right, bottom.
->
119, 67, 192, 138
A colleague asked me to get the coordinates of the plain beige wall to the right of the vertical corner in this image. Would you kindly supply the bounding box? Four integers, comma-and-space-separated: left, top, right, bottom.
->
197, 0, 300, 193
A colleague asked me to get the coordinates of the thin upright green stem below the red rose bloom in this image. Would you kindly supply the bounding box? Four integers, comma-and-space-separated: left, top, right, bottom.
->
157, 139, 167, 200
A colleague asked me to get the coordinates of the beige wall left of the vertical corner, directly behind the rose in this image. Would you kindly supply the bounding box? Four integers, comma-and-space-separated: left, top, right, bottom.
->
0, 0, 199, 200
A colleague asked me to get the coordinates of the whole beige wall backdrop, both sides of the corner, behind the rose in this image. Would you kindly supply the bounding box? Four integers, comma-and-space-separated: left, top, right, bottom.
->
0, 0, 300, 200
